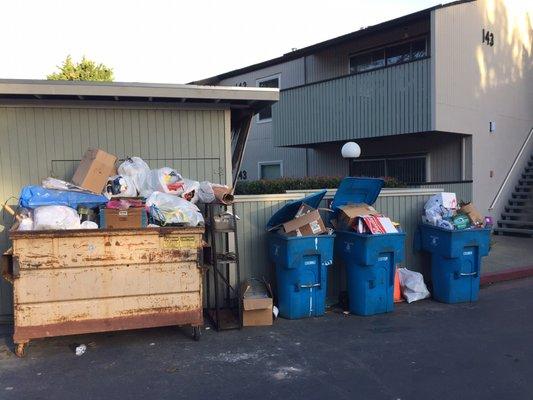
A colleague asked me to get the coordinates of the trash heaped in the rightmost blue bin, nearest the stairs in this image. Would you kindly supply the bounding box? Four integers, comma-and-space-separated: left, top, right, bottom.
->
422, 192, 492, 230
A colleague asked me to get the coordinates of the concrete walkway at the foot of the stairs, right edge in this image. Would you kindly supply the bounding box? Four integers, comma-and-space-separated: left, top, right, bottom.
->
481, 235, 533, 274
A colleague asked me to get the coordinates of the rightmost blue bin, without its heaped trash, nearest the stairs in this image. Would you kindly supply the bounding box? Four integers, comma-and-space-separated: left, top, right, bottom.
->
416, 224, 491, 303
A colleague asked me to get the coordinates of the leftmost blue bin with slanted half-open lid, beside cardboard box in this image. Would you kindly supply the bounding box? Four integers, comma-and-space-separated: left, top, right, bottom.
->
267, 190, 335, 319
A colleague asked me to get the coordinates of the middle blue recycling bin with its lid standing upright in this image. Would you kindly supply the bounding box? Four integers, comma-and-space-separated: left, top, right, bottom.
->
331, 178, 405, 315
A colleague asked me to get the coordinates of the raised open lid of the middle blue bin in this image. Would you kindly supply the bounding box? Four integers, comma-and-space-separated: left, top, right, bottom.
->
331, 177, 384, 211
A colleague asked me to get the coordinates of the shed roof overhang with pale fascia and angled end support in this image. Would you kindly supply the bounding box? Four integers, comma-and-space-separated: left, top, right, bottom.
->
0, 79, 279, 184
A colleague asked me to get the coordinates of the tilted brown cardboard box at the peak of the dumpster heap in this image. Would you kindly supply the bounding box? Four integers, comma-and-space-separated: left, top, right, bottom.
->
72, 149, 117, 194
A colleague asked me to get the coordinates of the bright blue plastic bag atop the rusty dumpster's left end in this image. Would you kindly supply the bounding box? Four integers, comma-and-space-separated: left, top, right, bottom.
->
19, 185, 108, 209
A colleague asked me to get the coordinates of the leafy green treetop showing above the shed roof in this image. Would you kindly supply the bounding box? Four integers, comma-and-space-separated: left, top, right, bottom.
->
46, 55, 113, 82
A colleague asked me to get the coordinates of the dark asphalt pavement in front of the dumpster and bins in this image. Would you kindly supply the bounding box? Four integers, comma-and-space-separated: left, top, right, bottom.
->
0, 279, 533, 400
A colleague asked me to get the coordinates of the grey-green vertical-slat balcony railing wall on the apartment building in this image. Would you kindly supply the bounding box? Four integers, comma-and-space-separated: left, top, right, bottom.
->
272, 58, 431, 146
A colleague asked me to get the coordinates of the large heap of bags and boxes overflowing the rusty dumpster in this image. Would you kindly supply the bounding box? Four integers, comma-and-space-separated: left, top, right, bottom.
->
12, 149, 233, 231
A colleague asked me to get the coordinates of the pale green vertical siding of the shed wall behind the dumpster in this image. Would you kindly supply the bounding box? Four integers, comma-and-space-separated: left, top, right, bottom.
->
0, 105, 226, 318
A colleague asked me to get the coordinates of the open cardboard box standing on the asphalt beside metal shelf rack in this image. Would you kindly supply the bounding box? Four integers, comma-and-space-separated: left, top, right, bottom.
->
241, 280, 273, 326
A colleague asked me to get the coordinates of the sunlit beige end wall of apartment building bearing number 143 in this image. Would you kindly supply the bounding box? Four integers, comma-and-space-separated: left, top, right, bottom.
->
431, 0, 533, 215
